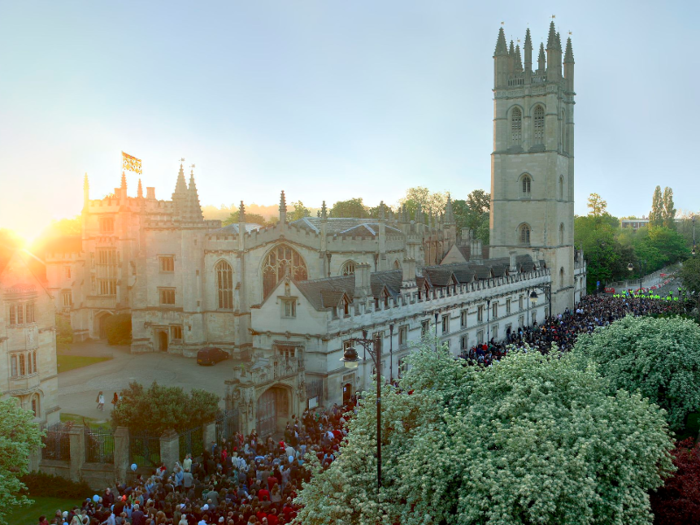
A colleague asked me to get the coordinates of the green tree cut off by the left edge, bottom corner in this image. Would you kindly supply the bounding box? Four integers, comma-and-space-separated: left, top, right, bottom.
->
0, 397, 43, 525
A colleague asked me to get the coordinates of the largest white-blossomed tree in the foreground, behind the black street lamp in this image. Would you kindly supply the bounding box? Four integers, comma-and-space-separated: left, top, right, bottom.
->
297, 349, 673, 525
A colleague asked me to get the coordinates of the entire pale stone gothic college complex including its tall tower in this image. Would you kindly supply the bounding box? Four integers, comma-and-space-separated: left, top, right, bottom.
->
47, 22, 585, 434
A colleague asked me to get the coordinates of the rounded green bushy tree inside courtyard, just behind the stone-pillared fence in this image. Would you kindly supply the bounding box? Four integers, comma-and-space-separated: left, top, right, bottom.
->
112, 382, 219, 436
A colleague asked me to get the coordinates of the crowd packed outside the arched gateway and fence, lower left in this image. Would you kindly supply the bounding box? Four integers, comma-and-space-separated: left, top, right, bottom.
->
39, 396, 357, 525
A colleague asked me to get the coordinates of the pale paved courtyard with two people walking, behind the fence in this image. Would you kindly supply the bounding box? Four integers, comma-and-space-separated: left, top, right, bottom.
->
58, 342, 232, 420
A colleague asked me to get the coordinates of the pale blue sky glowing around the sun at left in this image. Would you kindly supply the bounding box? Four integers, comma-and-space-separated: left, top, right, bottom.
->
0, 0, 700, 235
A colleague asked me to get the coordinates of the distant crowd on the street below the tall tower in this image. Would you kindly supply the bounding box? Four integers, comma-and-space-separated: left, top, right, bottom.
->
461, 293, 675, 366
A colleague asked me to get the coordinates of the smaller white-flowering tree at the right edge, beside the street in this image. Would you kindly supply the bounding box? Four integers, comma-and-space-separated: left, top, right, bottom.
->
575, 316, 700, 430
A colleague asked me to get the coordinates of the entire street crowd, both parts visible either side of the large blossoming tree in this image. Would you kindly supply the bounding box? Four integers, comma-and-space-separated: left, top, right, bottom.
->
39, 286, 688, 525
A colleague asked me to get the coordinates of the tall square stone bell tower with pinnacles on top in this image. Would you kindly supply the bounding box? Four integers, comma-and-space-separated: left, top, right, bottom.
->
490, 22, 575, 314
